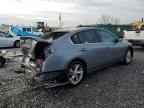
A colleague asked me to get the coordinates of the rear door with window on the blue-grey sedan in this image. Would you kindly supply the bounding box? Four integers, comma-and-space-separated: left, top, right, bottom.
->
71, 29, 108, 70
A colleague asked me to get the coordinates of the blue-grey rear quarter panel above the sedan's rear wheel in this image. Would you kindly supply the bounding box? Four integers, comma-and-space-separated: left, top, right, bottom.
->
42, 37, 83, 72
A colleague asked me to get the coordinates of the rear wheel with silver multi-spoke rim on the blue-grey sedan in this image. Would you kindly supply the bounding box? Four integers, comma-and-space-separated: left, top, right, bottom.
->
66, 61, 86, 86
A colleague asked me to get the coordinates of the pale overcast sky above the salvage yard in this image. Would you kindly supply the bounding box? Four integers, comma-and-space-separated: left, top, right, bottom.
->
0, 0, 144, 27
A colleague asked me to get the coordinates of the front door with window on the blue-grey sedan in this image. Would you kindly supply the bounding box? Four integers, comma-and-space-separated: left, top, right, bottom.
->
97, 30, 122, 62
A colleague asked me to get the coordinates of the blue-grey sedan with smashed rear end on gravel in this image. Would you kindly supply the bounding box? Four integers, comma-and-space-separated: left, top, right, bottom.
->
21, 27, 133, 86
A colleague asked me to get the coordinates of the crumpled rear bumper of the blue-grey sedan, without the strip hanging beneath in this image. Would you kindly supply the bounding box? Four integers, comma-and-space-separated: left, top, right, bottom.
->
21, 62, 63, 82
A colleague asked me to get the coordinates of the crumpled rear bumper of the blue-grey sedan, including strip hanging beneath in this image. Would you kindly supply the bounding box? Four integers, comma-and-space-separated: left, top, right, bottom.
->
21, 63, 68, 88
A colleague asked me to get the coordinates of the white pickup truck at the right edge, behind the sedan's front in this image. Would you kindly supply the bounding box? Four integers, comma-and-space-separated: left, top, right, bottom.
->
124, 30, 144, 46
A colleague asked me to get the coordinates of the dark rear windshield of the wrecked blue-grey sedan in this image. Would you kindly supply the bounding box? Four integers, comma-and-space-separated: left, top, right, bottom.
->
42, 32, 68, 40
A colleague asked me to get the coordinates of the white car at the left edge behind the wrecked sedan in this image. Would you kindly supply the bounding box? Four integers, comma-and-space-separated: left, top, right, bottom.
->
0, 31, 20, 47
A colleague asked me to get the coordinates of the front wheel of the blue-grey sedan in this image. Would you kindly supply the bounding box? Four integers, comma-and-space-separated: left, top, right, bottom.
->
124, 49, 132, 65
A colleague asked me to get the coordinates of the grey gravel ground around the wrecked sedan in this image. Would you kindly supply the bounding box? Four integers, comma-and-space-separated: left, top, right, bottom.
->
0, 50, 144, 108
